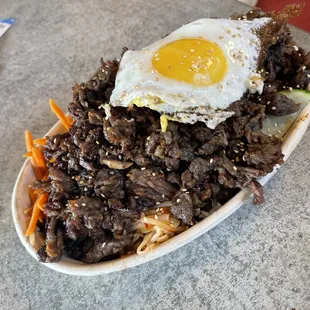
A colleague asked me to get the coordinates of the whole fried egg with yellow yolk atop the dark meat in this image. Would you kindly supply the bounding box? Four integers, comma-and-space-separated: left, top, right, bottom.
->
110, 17, 271, 129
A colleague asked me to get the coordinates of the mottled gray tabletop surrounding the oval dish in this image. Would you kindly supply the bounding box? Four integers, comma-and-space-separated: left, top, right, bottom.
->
0, 0, 310, 310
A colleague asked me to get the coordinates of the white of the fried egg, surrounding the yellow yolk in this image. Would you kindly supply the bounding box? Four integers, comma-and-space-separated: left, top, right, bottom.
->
110, 18, 271, 128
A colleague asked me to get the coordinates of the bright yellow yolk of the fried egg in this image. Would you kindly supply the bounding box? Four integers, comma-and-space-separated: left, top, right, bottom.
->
152, 38, 227, 86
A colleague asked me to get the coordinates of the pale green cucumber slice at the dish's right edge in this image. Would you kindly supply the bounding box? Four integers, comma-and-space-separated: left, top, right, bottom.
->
262, 89, 310, 139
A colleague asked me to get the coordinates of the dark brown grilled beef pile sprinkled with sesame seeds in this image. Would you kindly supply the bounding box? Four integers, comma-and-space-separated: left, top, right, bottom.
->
33, 9, 310, 263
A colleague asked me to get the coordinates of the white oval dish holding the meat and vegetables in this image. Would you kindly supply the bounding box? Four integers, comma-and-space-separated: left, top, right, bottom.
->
12, 98, 310, 276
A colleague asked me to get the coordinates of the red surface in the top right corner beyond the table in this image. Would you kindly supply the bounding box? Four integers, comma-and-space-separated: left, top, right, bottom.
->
257, 0, 310, 32
